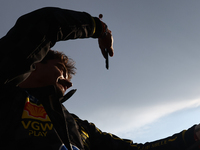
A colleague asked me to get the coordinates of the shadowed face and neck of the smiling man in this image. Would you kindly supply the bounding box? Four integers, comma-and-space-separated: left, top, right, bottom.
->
24, 59, 72, 96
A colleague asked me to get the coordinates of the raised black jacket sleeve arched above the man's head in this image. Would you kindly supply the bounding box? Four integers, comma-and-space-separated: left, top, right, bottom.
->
0, 7, 102, 86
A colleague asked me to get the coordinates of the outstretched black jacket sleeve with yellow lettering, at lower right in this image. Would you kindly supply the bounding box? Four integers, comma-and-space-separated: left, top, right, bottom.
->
74, 115, 199, 150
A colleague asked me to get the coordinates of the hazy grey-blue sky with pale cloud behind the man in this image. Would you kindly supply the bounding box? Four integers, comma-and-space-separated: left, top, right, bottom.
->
0, 0, 200, 142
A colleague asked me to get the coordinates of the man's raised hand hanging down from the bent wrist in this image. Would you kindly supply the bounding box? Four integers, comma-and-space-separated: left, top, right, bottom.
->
98, 29, 114, 58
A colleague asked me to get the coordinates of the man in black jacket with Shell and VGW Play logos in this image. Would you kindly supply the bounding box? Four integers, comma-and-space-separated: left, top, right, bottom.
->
0, 8, 200, 150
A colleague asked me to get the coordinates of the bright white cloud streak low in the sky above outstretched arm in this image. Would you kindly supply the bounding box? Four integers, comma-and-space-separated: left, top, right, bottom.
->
90, 98, 200, 134
